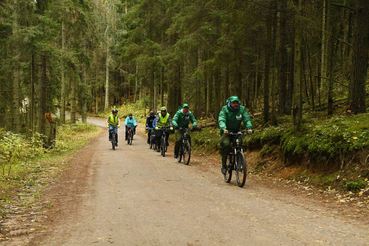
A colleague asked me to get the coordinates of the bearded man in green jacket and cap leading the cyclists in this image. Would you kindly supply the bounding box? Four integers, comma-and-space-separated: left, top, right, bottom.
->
218, 96, 252, 174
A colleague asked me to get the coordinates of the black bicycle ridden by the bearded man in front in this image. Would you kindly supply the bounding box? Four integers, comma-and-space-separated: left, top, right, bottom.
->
224, 132, 248, 187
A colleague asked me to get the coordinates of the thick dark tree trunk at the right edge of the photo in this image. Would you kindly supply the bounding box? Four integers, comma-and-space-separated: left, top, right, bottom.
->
350, 0, 369, 114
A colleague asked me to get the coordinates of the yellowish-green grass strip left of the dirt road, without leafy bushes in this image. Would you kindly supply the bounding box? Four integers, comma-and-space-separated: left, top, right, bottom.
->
0, 122, 99, 205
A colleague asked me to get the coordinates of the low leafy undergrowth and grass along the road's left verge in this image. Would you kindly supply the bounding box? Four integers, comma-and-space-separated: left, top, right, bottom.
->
0, 122, 99, 205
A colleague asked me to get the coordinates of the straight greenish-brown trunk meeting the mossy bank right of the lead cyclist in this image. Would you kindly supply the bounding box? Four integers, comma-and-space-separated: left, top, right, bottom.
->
293, 0, 303, 133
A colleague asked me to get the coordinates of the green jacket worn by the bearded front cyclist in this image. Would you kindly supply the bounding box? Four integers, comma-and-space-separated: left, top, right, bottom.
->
218, 104, 252, 133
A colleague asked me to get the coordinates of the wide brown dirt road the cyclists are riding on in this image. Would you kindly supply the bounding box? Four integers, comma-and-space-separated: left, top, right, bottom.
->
32, 119, 369, 245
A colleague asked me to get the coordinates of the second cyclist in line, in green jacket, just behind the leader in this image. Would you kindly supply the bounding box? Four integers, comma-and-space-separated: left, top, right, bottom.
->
172, 103, 197, 158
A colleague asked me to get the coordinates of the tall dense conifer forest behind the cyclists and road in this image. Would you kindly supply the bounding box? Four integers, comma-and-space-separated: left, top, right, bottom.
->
0, 0, 369, 134
